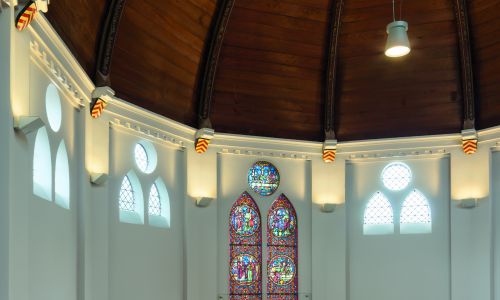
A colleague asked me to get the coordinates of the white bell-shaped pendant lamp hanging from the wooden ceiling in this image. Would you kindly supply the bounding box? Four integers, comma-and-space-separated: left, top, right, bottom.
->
385, 21, 411, 57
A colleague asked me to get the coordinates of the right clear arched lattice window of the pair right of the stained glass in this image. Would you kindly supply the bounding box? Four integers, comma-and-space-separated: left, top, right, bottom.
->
400, 190, 432, 234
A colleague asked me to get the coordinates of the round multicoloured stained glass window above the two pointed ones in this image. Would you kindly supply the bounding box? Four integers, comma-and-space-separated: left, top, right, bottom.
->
248, 161, 280, 196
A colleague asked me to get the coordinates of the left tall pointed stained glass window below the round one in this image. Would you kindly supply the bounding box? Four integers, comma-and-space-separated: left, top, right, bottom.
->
229, 192, 262, 300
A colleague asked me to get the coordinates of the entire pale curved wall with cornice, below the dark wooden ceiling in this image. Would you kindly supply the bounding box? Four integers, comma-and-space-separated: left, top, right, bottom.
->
0, 8, 500, 300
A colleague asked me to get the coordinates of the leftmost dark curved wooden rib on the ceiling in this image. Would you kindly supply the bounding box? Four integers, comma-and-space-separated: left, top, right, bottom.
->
94, 0, 126, 87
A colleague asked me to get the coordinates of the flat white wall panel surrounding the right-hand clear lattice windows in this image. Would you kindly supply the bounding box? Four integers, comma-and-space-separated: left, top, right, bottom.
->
347, 158, 451, 300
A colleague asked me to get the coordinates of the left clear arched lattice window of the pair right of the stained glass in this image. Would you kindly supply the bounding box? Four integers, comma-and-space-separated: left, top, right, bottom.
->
363, 192, 394, 235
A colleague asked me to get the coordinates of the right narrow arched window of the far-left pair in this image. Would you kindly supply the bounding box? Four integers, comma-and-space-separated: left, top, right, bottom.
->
55, 141, 70, 209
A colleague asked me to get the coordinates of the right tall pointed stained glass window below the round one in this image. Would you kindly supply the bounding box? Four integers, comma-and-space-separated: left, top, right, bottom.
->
267, 194, 298, 300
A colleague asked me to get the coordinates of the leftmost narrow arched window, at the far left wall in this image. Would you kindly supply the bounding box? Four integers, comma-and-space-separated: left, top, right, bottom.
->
33, 127, 52, 201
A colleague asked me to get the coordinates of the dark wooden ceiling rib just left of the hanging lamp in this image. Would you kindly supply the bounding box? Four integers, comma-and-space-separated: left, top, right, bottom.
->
324, 0, 344, 140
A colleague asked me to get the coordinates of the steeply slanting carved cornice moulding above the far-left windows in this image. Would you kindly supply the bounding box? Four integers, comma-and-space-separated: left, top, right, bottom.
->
30, 40, 85, 109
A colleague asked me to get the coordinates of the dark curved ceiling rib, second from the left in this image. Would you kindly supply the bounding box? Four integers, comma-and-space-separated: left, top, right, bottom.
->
198, 0, 235, 128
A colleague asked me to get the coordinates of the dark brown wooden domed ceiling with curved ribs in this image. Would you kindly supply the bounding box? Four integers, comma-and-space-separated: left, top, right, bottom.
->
47, 0, 500, 141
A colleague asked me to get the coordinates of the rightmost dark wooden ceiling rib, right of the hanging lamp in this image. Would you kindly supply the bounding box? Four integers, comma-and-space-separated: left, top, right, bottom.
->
453, 0, 476, 129
